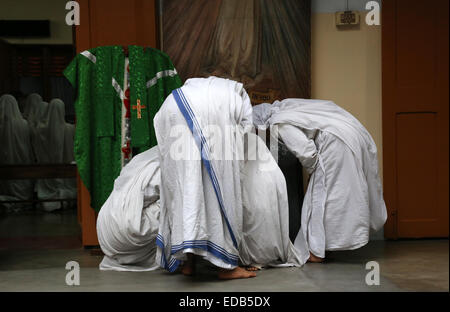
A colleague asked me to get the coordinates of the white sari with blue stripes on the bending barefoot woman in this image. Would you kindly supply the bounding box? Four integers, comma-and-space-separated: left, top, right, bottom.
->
154, 77, 252, 272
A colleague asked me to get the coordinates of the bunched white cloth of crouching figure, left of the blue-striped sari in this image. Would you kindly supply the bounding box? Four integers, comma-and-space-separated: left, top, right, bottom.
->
97, 147, 161, 271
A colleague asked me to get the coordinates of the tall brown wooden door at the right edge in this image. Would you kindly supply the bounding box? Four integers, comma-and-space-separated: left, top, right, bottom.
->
382, 0, 449, 238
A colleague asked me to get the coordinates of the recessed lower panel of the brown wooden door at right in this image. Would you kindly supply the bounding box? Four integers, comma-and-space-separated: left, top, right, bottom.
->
396, 113, 440, 237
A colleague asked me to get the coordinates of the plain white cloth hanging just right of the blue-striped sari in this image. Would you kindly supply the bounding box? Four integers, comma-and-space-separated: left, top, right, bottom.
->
239, 133, 309, 267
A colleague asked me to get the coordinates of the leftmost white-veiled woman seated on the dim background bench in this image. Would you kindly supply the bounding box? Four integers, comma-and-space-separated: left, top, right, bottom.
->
0, 94, 33, 208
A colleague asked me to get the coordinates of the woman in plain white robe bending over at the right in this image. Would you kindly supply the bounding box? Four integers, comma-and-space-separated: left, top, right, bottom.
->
253, 99, 387, 262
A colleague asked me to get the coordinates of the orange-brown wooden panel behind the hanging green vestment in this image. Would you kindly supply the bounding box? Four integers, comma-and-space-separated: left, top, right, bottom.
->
75, 0, 157, 246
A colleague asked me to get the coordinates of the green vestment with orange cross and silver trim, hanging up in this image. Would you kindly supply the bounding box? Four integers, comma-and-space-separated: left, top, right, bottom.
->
64, 46, 182, 211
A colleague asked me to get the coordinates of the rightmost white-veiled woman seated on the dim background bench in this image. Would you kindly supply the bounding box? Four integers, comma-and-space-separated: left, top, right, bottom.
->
33, 99, 76, 211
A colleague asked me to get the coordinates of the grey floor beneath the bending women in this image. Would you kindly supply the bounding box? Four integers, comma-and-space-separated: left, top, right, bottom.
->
0, 211, 449, 291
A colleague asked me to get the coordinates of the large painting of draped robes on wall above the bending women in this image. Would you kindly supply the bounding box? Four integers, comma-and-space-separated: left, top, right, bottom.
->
159, 0, 311, 104
